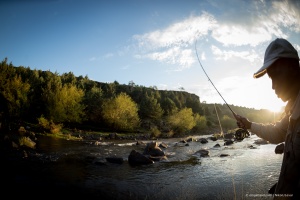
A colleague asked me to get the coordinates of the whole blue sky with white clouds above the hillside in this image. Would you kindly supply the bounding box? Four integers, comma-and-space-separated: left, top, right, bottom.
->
0, 0, 300, 111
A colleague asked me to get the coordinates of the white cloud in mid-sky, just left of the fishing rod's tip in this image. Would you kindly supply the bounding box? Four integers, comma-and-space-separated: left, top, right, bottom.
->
134, 13, 216, 70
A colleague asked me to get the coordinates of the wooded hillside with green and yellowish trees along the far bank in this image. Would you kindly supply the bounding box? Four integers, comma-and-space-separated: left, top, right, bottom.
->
0, 58, 274, 136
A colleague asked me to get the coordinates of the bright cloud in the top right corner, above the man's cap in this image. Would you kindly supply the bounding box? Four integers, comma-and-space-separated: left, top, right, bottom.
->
212, 0, 300, 47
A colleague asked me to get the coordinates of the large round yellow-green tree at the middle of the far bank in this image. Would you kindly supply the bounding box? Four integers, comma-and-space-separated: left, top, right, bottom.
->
102, 93, 140, 131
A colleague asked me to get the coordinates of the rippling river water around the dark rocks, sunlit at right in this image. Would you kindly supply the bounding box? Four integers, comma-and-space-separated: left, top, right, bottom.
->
5, 135, 282, 200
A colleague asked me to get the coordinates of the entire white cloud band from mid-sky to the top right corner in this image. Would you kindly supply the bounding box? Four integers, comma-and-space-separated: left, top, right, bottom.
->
133, 0, 300, 71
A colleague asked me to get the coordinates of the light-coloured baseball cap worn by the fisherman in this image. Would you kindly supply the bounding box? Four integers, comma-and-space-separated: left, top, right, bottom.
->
253, 38, 299, 78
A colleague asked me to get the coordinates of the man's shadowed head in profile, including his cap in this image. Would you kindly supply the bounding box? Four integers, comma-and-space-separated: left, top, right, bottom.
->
253, 38, 300, 102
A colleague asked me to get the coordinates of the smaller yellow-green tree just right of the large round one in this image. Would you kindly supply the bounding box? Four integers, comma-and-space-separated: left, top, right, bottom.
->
167, 108, 196, 133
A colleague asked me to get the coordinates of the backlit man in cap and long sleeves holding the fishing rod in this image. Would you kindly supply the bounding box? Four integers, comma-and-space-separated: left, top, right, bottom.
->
236, 38, 300, 199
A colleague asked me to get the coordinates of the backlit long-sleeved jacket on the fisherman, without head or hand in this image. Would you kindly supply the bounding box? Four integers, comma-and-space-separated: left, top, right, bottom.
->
251, 92, 300, 199
